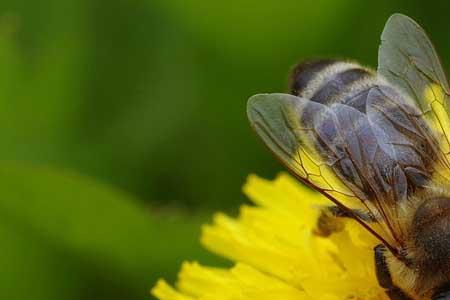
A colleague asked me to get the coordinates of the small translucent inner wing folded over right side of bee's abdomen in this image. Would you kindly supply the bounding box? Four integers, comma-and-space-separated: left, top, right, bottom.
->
366, 85, 438, 183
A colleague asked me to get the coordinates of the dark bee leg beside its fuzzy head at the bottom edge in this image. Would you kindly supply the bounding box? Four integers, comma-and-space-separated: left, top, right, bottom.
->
373, 244, 412, 300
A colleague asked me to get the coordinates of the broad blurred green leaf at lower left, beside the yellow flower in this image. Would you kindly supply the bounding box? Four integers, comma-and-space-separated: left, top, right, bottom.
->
0, 164, 224, 300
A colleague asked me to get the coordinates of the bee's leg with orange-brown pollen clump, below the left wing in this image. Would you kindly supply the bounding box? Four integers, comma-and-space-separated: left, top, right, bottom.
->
314, 206, 376, 237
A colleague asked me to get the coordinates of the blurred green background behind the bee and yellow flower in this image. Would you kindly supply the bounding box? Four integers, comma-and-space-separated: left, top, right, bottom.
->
0, 0, 450, 300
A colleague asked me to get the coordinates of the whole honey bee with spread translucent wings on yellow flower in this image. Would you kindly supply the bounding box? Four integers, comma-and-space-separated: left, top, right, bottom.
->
247, 14, 450, 300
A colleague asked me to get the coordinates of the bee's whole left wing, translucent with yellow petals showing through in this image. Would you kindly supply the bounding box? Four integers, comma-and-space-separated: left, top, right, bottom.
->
247, 94, 398, 253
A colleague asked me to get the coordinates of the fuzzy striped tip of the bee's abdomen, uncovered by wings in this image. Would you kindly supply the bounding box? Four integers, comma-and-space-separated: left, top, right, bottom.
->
290, 60, 377, 112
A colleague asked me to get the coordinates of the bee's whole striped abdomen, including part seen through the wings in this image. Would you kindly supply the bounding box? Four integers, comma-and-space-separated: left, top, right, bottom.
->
290, 60, 433, 199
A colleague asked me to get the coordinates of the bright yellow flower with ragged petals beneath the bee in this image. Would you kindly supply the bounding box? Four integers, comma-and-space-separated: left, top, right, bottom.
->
152, 174, 388, 300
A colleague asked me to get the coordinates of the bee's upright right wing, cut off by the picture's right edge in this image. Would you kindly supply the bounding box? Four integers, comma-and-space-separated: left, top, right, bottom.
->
378, 14, 450, 176
